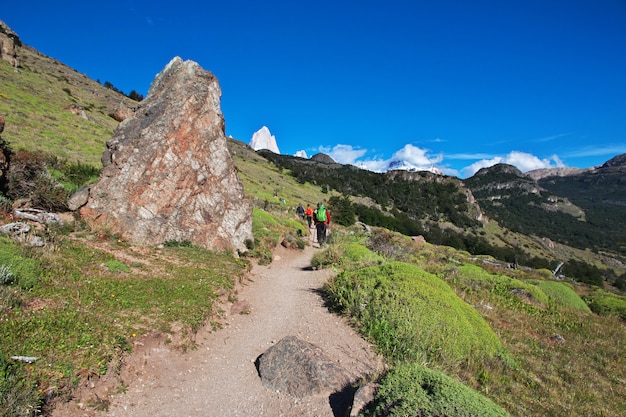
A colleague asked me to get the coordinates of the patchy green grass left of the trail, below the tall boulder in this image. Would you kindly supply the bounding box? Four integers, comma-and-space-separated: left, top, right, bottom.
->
0, 231, 247, 415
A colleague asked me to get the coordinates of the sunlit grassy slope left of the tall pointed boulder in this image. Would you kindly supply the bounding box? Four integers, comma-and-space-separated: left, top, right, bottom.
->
0, 47, 137, 166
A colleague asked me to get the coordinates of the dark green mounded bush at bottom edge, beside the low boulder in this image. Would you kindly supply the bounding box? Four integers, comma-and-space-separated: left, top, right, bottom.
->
359, 364, 509, 417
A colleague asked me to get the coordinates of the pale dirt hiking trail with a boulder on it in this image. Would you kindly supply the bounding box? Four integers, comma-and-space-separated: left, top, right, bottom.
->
55, 246, 379, 417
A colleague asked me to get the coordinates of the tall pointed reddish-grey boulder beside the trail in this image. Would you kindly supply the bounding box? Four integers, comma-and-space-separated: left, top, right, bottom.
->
80, 57, 252, 250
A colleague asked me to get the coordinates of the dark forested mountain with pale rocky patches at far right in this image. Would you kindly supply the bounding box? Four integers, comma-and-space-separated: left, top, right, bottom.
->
464, 154, 626, 255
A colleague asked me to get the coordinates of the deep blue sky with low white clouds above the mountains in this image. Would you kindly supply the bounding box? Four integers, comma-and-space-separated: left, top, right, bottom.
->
0, 0, 626, 178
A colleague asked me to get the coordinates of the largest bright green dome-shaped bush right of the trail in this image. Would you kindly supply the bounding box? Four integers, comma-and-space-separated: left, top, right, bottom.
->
325, 262, 503, 365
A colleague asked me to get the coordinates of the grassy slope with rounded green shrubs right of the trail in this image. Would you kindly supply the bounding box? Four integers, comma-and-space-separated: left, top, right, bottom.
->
314, 229, 626, 417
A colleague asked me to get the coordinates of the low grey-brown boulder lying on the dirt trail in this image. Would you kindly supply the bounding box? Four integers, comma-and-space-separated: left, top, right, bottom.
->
257, 336, 349, 398
